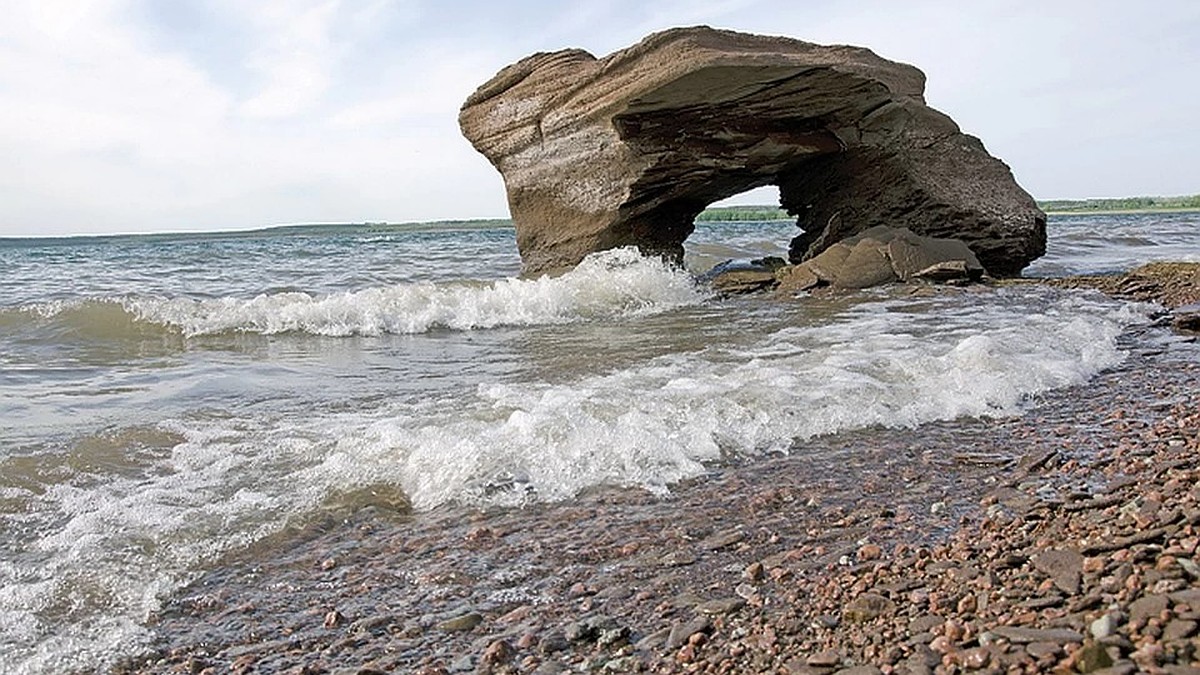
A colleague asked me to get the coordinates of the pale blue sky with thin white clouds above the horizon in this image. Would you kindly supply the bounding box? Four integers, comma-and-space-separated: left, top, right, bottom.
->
0, 0, 1200, 237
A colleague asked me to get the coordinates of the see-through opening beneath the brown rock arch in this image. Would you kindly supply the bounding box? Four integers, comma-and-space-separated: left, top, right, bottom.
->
683, 185, 799, 275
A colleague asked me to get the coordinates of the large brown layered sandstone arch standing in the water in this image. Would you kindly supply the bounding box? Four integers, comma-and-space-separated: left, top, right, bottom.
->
458, 26, 1045, 275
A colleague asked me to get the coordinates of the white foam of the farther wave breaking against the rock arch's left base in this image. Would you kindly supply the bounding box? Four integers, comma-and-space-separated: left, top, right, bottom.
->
126, 249, 704, 336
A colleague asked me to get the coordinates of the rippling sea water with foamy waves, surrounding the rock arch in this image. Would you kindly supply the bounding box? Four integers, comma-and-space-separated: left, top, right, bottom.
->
0, 214, 1200, 674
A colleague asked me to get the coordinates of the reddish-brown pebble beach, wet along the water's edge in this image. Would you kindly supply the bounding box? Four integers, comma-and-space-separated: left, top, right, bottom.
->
118, 269, 1200, 675
